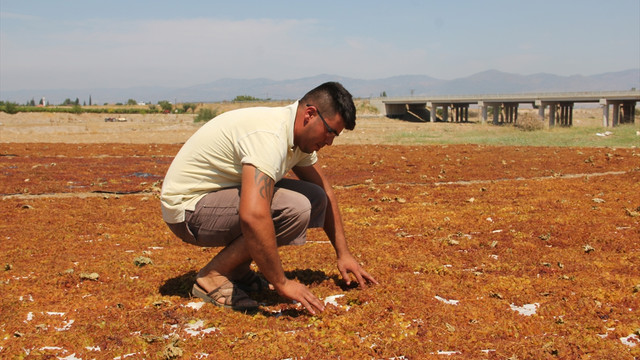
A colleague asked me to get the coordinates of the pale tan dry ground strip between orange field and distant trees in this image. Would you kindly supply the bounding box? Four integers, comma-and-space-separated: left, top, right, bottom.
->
0, 108, 602, 145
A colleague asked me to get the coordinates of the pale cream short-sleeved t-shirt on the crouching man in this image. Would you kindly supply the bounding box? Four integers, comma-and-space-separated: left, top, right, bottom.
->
160, 102, 318, 224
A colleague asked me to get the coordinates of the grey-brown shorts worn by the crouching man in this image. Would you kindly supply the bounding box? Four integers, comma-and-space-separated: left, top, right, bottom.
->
169, 179, 327, 247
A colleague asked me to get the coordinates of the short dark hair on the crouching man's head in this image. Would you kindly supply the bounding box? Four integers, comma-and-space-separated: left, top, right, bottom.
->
300, 81, 356, 130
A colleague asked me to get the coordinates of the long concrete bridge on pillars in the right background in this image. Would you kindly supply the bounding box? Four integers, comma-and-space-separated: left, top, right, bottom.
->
372, 90, 640, 127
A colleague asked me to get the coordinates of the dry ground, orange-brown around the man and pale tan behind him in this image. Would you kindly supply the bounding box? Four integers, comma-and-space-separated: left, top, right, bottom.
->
0, 107, 640, 359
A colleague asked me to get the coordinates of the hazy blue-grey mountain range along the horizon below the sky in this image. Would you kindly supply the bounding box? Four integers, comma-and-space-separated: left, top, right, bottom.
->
0, 69, 640, 104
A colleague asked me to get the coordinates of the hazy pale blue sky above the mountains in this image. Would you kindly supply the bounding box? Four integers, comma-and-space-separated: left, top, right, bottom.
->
0, 0, 640, 91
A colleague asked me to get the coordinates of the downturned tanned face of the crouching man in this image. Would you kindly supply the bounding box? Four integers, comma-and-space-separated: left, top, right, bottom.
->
298, 105, 344, 153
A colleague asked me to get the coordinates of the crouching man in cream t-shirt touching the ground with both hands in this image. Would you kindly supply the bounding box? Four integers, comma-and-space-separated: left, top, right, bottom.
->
161, 82, 377, 314
